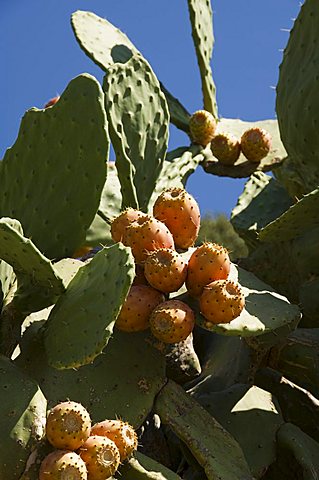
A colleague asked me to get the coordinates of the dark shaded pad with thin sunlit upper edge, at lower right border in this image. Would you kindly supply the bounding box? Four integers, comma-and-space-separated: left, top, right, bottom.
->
255, 367, 319, 442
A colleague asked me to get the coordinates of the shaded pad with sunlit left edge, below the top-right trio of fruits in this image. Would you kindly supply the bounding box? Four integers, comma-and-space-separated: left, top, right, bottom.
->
231, 172, 292, 249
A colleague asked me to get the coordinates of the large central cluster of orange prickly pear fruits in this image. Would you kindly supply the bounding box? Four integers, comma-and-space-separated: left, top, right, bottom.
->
111, 187, 245, 343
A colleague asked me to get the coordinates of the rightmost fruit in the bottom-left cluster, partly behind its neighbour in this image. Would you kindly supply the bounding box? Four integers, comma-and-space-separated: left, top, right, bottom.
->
91, 420, 137, 462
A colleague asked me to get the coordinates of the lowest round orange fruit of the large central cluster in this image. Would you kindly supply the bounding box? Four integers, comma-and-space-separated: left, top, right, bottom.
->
150, 300, 195, 343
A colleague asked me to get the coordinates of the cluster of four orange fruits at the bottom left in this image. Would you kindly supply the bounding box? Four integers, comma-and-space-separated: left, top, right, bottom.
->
39, 401, 137, 480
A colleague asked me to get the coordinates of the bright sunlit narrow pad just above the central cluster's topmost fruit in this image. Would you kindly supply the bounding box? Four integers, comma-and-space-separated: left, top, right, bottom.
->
149, 145, 204, 212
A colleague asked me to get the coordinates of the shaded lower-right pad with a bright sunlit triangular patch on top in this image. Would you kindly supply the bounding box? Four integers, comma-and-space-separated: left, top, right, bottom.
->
196, 384, 284, 478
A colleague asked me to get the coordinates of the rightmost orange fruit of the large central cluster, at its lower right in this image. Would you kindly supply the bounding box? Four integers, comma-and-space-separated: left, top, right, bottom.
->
199, 280, 245, 328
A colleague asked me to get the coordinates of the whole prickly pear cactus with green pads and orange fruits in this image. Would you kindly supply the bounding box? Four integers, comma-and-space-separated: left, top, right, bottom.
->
0, 0, 319, 480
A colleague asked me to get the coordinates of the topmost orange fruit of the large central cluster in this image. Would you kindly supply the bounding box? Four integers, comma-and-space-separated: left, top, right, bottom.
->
153, 187, 200, 249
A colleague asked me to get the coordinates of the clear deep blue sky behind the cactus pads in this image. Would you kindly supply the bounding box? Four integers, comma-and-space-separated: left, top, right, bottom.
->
0, 0, 300, 215
